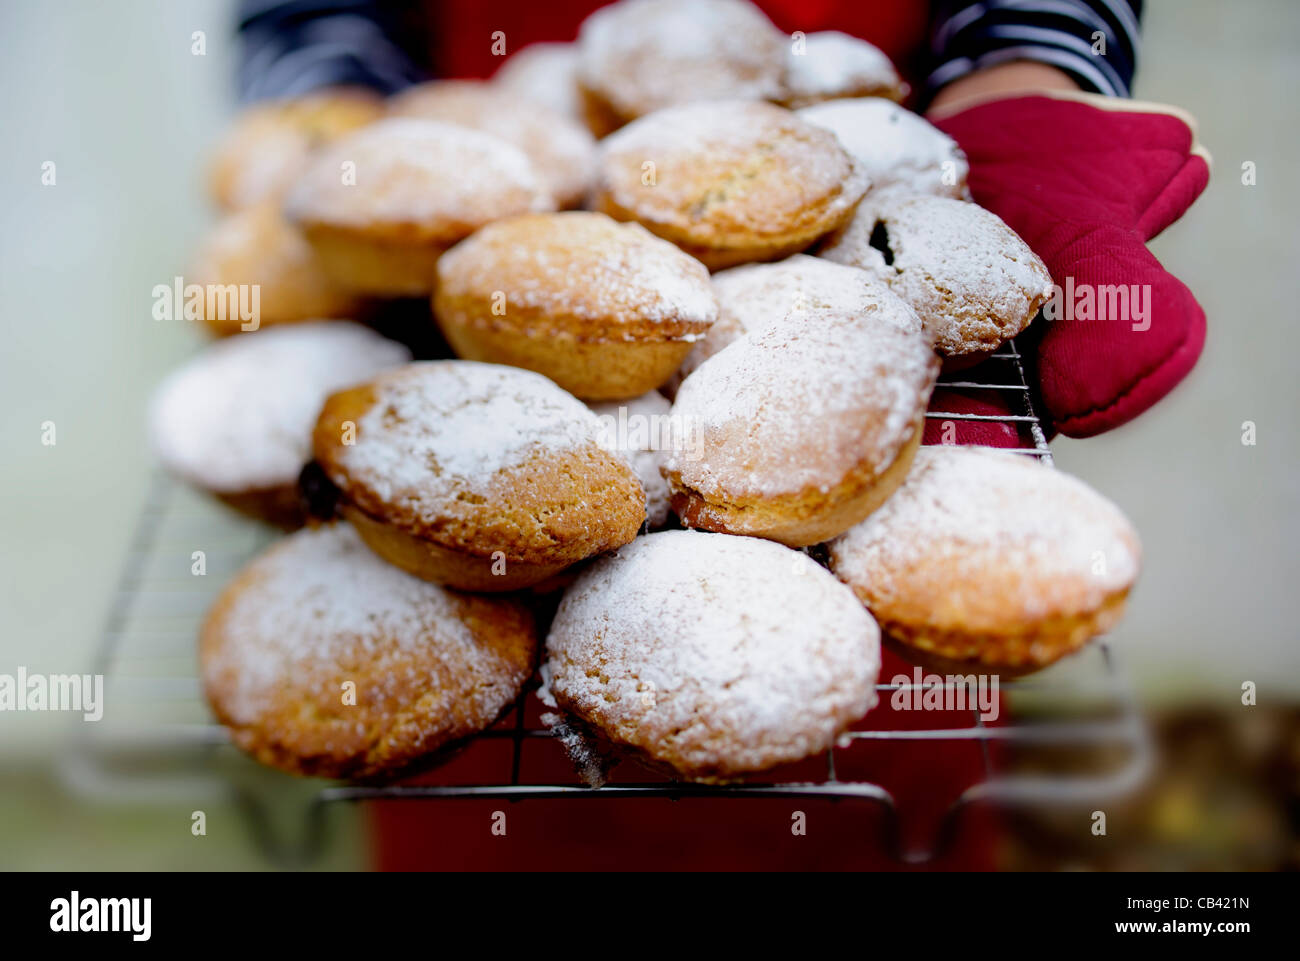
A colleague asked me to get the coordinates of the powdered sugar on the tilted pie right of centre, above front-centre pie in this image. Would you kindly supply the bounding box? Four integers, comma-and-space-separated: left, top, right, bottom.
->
664, 299, 939, 501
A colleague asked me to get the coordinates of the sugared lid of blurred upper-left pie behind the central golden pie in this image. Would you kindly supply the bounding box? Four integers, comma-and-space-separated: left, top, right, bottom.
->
285, 117, 555, 242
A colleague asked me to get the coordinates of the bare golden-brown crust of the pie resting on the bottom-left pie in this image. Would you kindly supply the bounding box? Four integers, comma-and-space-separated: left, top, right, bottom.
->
313, 362, 645, 579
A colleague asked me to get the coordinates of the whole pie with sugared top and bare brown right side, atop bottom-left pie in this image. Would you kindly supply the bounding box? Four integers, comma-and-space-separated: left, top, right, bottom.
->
313, 360, 645, 590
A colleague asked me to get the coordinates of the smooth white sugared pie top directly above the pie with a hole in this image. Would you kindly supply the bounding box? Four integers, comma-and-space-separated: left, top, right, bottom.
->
798, 98, 970, 200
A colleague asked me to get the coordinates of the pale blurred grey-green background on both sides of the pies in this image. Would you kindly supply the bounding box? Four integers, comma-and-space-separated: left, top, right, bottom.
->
0, 0, 1300, 866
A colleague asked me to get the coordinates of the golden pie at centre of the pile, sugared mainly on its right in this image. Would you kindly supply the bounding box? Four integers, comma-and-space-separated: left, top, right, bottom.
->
433, 212, 718, 399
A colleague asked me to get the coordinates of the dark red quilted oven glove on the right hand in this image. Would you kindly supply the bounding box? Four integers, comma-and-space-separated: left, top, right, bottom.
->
933, 94, 1209, 437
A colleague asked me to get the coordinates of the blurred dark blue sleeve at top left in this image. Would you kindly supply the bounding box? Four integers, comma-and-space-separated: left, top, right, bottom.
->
239, 0, 424, 101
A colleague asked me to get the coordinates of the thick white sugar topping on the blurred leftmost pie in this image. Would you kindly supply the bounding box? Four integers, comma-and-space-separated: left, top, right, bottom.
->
150, 321, 411, 493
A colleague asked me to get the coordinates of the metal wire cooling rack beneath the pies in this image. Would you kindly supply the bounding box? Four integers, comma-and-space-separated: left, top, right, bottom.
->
62, 343, 1153, 863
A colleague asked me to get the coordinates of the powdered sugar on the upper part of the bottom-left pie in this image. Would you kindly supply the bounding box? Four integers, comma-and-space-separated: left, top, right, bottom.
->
204, 524, 496, 723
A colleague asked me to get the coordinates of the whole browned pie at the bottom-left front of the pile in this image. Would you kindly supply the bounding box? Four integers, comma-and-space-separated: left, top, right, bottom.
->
199, 525, 537, 779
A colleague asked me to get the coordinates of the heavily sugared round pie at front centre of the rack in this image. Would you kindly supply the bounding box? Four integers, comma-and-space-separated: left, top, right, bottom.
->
545, 531, 880, 779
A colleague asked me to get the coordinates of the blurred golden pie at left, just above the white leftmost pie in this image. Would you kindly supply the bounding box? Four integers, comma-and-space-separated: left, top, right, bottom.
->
186, 202, 365, 337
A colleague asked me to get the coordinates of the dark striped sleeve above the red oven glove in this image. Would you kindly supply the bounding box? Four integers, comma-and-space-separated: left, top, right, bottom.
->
926, 0, 1143, 96
